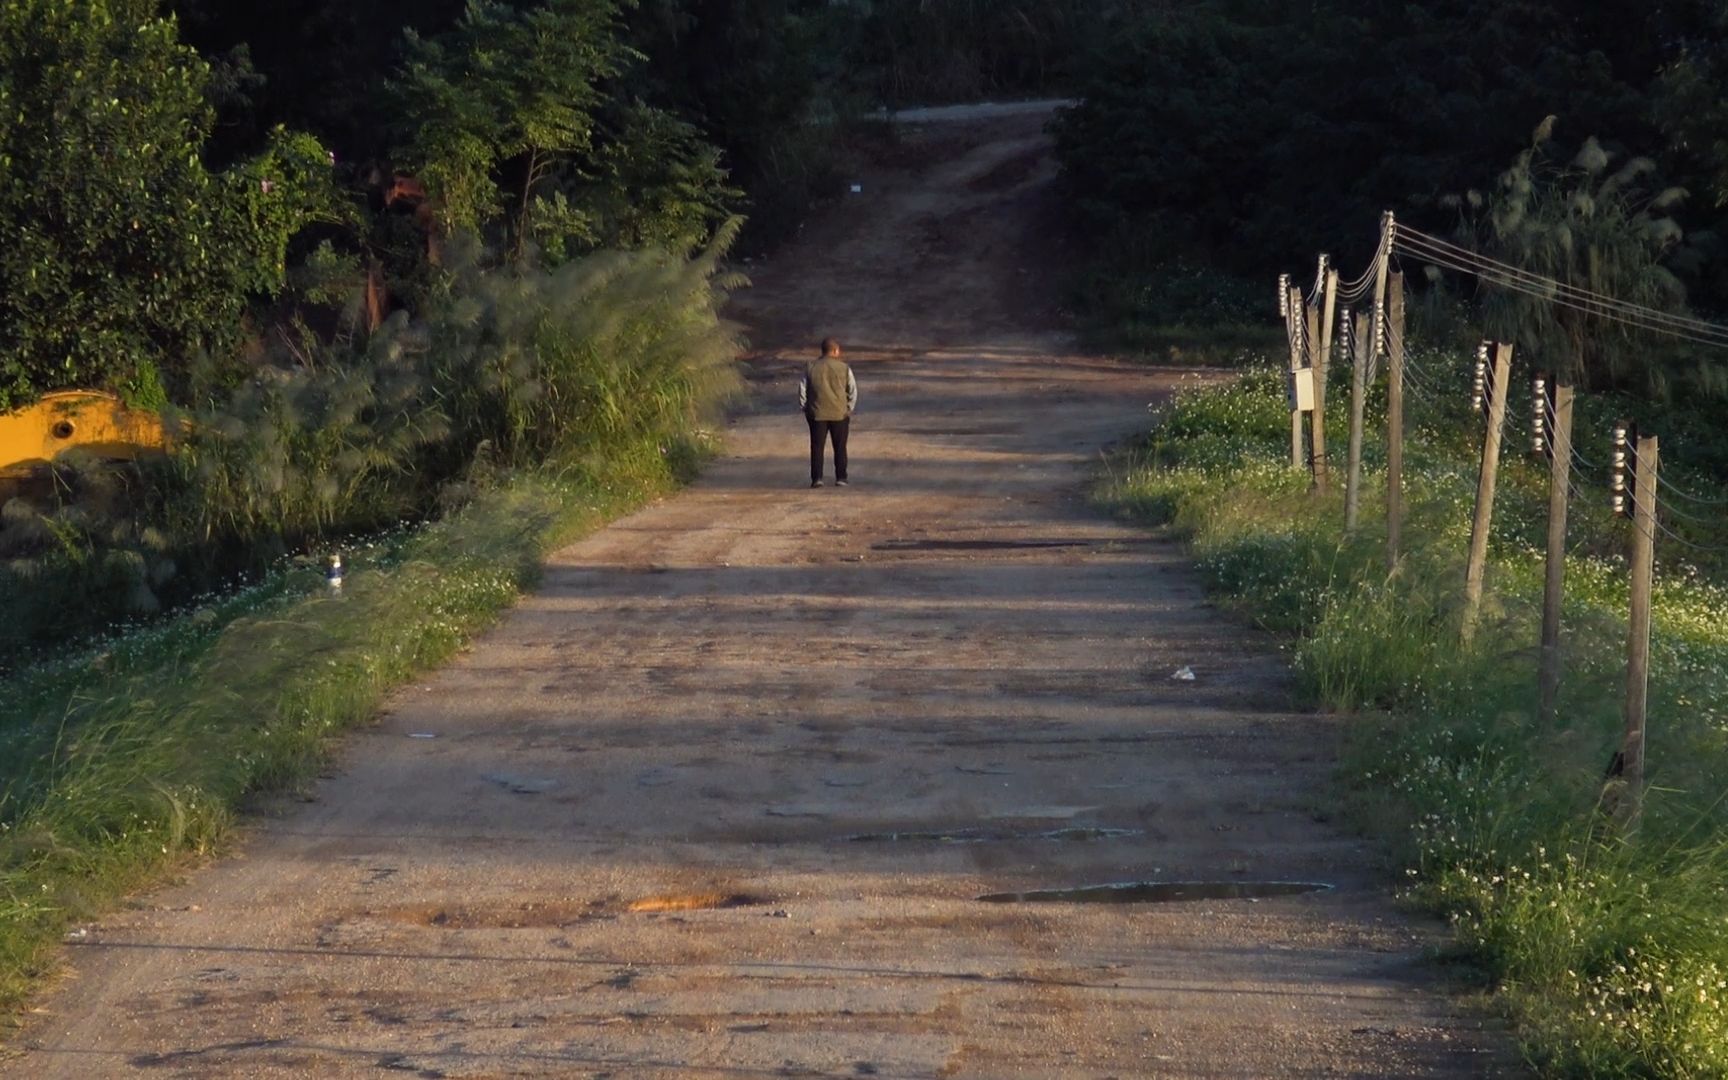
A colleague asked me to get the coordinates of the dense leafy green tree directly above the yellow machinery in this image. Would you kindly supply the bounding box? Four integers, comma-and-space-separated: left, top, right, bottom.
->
0, 0, 330, 408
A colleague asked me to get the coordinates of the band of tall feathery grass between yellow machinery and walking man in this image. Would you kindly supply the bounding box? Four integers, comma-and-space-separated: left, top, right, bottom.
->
0, 221, 738, 660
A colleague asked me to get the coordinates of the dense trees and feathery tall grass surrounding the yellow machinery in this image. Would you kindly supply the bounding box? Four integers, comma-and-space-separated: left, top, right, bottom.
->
0, 0, 760, 655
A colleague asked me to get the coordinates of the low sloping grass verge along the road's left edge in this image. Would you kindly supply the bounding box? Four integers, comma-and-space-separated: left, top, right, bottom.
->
0, 442, 703, 1018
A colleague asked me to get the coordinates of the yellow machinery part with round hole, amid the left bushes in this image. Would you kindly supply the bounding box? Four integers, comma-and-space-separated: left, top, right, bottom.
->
0, 391, 168, 501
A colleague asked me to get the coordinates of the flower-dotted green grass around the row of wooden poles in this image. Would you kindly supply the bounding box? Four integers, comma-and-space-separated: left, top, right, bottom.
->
1096, 353, 1728, 1078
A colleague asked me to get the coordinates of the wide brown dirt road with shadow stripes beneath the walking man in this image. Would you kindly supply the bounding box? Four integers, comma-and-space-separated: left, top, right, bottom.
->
0, 105, 1498, 1077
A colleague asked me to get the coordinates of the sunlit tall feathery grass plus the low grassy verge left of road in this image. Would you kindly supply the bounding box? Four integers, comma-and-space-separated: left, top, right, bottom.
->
0, 228, 736, 1014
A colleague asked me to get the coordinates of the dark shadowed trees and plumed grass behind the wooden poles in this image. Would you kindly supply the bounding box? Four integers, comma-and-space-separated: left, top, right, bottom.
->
1056, 0, 1728, 389
